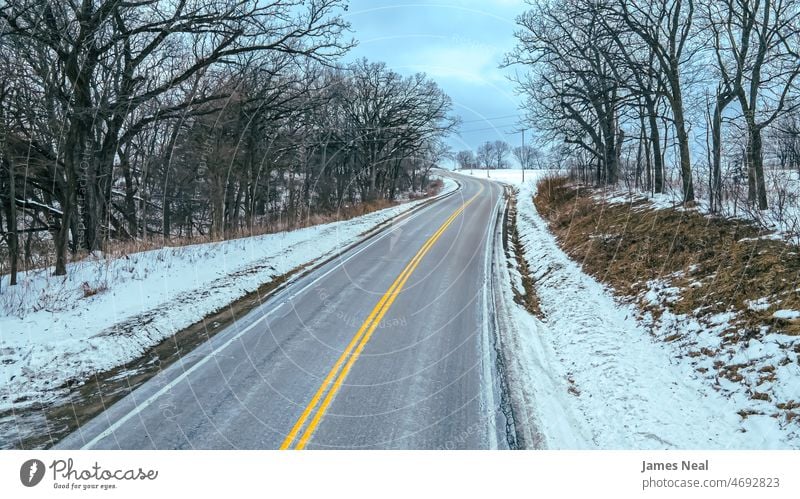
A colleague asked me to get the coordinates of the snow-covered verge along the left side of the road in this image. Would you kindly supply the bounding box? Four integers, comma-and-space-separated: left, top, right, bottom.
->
0, 177, 458, 412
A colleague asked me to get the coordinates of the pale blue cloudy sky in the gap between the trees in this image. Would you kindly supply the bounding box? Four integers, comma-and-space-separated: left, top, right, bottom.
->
346, 0, 526, 156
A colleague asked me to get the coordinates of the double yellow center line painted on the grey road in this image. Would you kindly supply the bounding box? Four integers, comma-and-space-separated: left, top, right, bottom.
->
280, 184, 483, 449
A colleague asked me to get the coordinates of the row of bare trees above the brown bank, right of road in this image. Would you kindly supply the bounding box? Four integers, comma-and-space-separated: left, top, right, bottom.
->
505, 0, 800, 210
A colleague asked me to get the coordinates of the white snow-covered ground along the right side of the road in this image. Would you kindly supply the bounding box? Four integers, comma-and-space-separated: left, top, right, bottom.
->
454, 170, 800, 449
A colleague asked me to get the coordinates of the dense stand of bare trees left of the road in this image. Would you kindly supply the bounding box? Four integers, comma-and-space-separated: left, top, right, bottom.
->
0, 0, 454, 283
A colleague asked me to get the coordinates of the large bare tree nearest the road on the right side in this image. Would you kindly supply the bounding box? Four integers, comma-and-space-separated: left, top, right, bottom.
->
505, 1, 621, 184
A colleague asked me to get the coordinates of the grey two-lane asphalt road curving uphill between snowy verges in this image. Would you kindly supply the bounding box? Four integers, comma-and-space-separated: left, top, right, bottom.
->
56, 176, 507, 449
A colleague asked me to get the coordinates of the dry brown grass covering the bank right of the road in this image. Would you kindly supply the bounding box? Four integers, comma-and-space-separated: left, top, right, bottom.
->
534, 179, 800, 341
